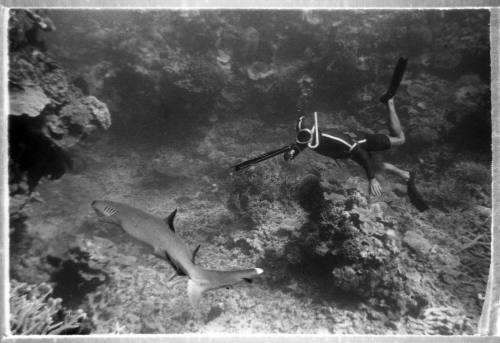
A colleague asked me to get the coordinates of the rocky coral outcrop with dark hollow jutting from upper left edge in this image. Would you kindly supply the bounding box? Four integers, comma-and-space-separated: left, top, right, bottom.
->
9, 10, 111, 199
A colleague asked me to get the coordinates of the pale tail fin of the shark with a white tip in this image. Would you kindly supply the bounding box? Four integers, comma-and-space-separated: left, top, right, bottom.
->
188, 268, 264, 306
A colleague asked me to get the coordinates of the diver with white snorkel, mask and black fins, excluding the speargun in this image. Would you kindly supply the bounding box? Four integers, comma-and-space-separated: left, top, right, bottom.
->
284, 58, 429, 211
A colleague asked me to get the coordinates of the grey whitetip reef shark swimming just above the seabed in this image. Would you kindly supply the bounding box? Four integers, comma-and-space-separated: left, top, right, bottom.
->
92, 200, 263, 306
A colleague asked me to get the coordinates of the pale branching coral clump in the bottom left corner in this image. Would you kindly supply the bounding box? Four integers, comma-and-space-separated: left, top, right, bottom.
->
10, 279, 86, 335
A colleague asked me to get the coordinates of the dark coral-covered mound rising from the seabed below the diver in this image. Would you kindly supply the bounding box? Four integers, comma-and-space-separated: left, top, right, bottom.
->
286, 184, 428, 317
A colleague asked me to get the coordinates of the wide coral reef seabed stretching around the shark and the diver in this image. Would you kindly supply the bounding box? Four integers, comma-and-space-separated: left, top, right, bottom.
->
9, 10, 491, 335
